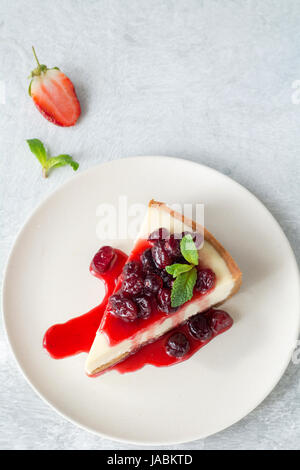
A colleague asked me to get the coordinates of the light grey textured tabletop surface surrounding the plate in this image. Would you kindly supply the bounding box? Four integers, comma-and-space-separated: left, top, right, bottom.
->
0, 0, 300, 449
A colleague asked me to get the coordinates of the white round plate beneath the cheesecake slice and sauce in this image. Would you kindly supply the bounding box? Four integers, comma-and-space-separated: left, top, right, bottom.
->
3, 157, 299, 445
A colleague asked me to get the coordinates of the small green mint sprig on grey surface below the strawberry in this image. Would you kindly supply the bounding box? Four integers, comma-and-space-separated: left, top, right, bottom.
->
27, 139, 79, 178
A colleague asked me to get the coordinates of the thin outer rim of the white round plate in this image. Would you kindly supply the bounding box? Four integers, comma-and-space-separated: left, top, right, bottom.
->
2, 155, 300, 447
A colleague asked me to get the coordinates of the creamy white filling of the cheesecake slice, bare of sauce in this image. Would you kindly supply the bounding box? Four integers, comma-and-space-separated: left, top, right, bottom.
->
85, 202, 234, 375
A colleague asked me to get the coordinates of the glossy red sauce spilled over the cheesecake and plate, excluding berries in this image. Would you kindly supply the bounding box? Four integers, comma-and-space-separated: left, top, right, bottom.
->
43, 246, 233, 374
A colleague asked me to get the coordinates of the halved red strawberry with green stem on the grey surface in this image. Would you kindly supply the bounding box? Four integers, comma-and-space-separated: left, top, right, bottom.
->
29, 48, 81, 127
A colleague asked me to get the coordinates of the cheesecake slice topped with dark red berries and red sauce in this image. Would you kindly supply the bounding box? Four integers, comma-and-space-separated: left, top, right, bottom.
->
85, 200, 242, 375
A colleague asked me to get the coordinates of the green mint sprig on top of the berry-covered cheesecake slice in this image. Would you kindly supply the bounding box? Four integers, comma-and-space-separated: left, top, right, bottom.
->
166, 234, 199, 307
